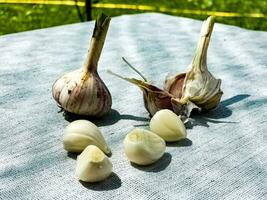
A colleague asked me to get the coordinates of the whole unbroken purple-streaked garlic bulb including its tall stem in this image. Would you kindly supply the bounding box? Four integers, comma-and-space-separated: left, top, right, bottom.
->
52, 14, 112, 117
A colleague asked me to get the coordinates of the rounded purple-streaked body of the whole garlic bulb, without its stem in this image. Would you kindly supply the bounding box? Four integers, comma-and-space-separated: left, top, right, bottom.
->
53, 70, 112, 117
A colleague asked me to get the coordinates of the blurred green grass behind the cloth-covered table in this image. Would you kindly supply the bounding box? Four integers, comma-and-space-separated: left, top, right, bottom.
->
0, 0, 267, 35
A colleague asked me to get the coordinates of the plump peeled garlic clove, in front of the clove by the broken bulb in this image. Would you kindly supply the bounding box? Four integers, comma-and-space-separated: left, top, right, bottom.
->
123, 128, 166, 165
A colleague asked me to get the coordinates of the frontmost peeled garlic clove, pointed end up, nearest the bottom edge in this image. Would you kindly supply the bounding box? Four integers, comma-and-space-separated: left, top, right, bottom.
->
76, 145, 112, 182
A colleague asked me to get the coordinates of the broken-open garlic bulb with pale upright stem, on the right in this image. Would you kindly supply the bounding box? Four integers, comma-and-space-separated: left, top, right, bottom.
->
164, 17, 223, 112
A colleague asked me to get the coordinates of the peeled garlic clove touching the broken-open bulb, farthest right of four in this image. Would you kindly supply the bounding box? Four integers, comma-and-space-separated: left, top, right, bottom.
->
149, 109, 187, 142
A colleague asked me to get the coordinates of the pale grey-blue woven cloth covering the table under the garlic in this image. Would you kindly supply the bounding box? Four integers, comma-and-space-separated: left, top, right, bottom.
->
0, 14, 267, 200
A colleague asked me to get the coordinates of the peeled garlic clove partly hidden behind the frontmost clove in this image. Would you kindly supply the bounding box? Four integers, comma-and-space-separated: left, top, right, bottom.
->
63, 120, 111, 155
